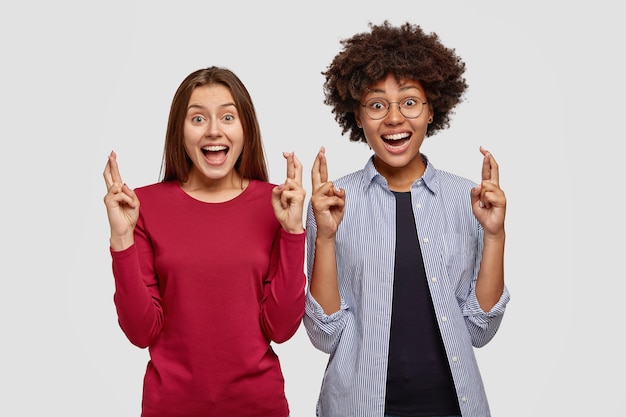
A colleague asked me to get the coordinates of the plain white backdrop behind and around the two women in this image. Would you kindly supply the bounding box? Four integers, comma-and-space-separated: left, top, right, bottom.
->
0, 0, 626, 417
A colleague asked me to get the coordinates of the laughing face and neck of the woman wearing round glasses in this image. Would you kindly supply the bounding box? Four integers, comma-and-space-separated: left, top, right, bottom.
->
355, 74, 432, 189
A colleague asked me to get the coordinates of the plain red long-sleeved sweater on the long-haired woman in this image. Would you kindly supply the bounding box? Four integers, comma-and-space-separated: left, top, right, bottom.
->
111, 180, 306, 417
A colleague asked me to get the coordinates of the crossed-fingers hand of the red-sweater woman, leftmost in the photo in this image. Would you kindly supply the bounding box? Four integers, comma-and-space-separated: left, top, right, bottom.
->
103, 152, 139, 250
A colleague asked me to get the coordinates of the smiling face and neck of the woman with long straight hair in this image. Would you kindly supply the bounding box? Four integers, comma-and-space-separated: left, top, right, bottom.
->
184, 84, 244, 187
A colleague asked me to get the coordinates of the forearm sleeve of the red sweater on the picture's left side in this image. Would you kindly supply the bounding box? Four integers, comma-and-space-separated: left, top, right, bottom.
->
110, 218, 163, 348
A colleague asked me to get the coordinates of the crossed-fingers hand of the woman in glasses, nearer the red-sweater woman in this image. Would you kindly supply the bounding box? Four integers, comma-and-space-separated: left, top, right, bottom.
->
311, 147, 346, 239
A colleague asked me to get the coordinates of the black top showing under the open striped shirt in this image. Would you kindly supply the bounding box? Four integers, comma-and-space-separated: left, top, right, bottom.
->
385, 192, 461, 417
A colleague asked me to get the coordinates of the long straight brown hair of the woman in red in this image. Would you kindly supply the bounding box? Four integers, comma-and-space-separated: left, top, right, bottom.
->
161, 66, 268, 182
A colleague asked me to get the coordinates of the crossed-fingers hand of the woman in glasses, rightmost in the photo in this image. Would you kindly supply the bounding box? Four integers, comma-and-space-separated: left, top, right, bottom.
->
470, 146, 506, 236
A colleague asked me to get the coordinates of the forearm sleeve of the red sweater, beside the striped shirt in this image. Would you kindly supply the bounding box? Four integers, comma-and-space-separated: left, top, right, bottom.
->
261, 228, 306, 343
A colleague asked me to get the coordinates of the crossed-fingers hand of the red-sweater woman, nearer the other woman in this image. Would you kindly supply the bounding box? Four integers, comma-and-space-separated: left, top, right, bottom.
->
272, 152, 306, 233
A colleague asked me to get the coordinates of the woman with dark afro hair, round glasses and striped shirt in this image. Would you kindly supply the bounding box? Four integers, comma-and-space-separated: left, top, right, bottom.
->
304, 21, 509, 417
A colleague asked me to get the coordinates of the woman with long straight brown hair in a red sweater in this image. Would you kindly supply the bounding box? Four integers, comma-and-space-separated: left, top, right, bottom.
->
103, 67, 306, 417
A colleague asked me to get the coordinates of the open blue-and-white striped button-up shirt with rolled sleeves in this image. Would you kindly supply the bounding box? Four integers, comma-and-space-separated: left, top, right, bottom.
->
303, 156, 509, 417
